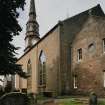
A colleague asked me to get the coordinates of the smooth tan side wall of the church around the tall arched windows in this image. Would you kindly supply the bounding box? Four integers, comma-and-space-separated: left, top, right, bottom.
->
16, 26, 60, 93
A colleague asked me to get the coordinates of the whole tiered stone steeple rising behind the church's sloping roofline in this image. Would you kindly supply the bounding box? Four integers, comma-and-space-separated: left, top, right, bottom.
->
24, 0, 40, 52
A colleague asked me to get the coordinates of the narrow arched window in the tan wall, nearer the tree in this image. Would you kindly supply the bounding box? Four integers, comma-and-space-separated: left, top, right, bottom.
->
27, 59, 32, 90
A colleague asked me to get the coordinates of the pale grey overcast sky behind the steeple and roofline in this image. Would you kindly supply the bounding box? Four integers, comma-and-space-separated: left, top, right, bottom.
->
13, 0, 105, 57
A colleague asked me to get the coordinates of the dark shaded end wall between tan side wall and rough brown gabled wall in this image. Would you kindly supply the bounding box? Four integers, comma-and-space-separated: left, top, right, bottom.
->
59, 13, 88, 94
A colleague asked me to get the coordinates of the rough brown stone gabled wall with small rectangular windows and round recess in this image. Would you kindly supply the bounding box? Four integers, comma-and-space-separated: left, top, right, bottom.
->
72, 16, 105, 96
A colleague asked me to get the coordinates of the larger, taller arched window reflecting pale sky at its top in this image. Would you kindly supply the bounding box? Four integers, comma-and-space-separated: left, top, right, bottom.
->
39, 51, 46, 86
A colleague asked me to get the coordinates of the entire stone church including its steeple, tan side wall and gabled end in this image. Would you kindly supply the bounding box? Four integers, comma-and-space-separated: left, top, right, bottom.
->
15, 0, 105, 95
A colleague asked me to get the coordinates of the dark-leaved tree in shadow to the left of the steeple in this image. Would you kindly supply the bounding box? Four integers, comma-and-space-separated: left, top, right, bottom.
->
0, 0, 26, 77
